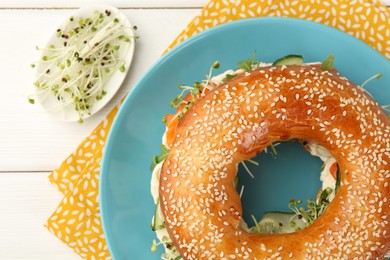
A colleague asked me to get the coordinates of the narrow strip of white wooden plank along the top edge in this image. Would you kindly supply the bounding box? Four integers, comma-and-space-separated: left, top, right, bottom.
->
0, 0, 208, 8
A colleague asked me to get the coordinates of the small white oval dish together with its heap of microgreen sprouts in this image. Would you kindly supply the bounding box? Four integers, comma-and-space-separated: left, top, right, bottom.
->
30, 5, 136, 123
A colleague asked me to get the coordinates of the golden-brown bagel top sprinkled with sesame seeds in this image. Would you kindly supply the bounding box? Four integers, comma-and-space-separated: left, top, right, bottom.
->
159, 65, 390, 259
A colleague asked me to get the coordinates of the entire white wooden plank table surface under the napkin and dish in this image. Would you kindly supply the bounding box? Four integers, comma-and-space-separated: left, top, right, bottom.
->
0, 0, 390, 259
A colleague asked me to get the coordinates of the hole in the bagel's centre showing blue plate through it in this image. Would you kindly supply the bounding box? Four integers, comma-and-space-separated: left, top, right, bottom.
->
237, 141, 334, 235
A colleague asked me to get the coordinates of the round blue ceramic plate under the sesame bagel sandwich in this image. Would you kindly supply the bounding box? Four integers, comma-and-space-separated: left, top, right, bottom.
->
100, 18, 390, 259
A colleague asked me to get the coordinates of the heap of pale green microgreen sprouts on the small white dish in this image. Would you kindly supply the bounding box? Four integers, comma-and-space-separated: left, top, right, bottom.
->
31, 10, 136, 123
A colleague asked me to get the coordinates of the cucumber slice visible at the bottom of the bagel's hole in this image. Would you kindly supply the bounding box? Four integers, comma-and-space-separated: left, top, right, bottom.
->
253, 212, 306, 234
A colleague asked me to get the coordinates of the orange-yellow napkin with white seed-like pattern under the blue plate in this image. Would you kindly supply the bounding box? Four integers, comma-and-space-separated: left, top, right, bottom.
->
46, 0, 390, 259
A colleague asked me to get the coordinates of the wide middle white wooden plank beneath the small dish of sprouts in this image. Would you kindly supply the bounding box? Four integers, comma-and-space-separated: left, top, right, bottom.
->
0, 9, 199, 171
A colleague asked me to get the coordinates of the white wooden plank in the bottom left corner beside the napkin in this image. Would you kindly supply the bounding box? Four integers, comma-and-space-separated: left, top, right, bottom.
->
0, 172, 80, 260
